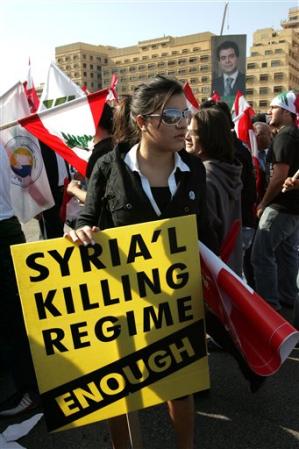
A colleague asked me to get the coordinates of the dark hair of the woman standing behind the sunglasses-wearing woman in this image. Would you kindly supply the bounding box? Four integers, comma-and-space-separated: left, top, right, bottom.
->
194, 107, 235, 162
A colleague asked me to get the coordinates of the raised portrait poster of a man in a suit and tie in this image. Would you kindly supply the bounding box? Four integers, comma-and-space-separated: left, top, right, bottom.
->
211, 34, 246, 103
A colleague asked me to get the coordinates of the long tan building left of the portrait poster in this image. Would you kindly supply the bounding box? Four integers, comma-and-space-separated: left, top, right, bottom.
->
56, 32, 212, 100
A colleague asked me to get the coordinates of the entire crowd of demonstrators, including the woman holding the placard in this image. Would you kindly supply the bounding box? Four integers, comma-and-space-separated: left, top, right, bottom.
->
0, 75, 299, 449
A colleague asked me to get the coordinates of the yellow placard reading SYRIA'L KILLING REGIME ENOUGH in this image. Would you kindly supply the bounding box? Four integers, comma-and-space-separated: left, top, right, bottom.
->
12, 216, 209, 430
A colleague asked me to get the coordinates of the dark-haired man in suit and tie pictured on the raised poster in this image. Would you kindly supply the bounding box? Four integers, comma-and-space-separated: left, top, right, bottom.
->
212, 40, 245, 97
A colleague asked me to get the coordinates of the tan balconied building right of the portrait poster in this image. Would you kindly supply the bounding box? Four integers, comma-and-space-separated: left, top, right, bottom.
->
246, 8, 299, 111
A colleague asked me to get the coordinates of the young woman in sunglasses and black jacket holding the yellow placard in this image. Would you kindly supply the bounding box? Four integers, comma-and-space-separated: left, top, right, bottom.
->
69, 76, 218, 449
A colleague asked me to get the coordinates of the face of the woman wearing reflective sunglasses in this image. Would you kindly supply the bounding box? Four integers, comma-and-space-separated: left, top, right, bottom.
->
141, 94, 191, 152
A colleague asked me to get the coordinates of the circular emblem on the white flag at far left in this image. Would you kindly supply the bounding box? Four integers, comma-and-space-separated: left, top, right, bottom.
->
5, 136, 43, 187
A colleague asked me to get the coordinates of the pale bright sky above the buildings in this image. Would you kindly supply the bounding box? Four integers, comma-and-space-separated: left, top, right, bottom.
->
0, 0, 298, 95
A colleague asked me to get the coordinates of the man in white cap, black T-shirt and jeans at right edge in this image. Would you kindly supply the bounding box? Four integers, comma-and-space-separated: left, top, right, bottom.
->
252, 91, 299, 316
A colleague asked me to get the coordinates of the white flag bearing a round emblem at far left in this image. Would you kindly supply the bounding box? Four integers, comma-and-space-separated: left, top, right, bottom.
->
0, 82, 54, 223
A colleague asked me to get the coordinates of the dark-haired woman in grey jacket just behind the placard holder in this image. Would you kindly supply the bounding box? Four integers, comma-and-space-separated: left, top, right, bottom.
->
186, 108, 242, 276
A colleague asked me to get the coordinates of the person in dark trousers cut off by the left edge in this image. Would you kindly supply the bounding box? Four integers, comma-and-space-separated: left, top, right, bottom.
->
0, 145, 38, 418
